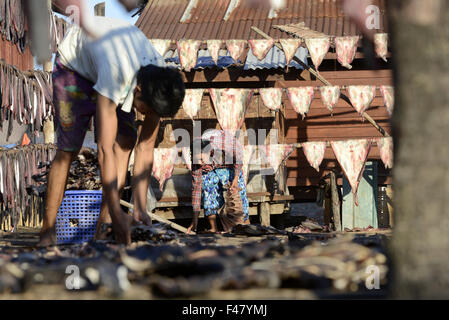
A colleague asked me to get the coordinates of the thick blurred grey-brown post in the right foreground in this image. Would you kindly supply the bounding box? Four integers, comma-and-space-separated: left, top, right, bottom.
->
387, 0, 449, 299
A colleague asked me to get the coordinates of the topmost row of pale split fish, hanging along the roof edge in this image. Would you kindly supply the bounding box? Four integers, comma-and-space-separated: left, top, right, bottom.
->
150, 33, 388, 72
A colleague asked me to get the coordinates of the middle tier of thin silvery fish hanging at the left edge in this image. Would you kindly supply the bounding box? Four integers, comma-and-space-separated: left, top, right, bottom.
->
0, 63, 53, 139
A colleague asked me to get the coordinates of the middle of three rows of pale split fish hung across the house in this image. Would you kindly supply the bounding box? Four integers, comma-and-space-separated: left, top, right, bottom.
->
182, 86, 394, 130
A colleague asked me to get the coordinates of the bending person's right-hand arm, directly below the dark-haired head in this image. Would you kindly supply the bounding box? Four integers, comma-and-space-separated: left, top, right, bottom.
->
132, 109, 160, 225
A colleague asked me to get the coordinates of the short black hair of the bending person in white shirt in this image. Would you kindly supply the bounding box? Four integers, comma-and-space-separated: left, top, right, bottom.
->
137, 64, 185, 117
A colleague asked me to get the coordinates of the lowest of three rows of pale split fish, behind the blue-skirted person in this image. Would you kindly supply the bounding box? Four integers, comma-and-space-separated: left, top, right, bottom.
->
153, 137, 393, 205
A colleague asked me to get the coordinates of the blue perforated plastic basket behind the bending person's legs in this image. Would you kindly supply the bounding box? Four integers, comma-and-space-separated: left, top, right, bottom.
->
56, 190, 102, 244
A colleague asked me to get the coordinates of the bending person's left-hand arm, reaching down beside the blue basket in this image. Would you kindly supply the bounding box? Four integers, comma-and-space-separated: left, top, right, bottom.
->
96, 94, 131, 244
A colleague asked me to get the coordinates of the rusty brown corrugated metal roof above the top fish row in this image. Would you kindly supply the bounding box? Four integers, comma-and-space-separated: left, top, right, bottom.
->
136, 0, 388, 40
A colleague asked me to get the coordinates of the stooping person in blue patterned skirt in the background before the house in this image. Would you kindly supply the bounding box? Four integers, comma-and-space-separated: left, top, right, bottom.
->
188, 130, 249, 233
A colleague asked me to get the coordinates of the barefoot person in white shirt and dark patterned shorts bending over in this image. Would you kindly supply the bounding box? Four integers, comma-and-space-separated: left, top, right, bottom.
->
39, 17, 184, 246
